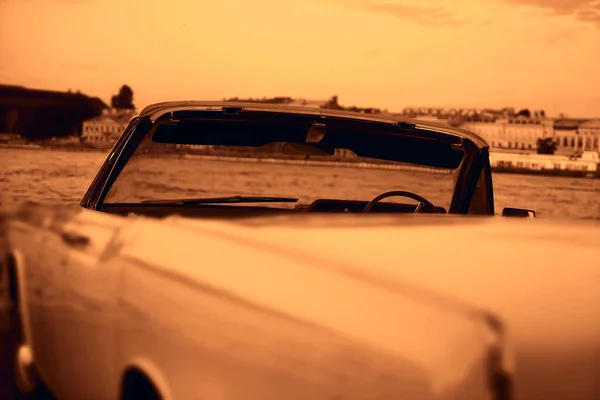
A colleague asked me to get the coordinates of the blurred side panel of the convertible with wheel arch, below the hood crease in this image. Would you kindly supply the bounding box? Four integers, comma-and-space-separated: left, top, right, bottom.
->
9, 206, 510, 399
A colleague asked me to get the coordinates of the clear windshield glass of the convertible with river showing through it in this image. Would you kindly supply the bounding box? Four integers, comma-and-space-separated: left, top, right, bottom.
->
105, 141, 459, 210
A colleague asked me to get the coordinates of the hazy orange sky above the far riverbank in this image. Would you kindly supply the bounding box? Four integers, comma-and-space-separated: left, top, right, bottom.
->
0, 0, 600, 117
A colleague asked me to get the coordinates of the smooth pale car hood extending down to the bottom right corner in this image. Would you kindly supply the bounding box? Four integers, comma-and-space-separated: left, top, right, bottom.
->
159, 216, 600, 399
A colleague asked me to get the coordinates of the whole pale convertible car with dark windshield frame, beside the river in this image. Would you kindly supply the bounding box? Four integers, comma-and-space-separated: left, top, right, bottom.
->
5, 103, 600, 400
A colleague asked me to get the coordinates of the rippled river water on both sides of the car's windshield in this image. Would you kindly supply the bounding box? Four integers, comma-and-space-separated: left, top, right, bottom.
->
0, 149, 600, 220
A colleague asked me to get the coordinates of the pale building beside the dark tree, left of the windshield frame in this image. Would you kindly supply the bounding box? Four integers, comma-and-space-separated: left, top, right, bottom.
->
81, 108, 135, 147
